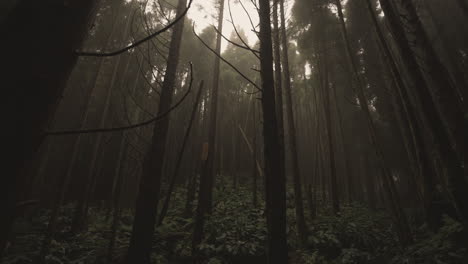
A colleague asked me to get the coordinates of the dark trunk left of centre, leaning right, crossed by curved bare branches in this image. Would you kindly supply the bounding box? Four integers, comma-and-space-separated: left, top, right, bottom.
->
126, 0, 187, 264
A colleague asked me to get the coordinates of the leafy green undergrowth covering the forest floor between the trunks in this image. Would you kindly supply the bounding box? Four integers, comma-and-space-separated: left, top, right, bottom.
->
2, 177, 468, 264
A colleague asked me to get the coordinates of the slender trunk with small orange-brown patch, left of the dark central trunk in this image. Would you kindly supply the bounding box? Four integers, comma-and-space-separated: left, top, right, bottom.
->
192, 0, 224, 255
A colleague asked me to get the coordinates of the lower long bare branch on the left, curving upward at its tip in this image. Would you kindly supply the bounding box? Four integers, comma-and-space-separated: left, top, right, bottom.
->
44, 63, 193, 136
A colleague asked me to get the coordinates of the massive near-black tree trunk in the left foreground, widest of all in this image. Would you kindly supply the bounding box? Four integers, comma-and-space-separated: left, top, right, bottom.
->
0, 0, 96, 258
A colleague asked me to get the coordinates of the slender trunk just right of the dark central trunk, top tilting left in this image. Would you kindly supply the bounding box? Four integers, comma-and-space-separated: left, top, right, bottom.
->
276, 0, 307, 245
